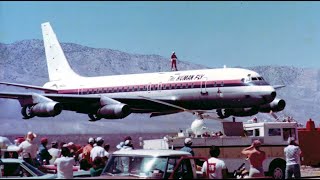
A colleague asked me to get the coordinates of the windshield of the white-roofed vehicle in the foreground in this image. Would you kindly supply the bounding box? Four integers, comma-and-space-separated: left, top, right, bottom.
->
102, 156, 180, 178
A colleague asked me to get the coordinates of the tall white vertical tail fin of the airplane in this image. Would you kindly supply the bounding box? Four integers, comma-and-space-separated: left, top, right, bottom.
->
41, 22, 81, 81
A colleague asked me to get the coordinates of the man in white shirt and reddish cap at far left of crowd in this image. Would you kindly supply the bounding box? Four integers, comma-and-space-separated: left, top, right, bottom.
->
17, 131, 38, 166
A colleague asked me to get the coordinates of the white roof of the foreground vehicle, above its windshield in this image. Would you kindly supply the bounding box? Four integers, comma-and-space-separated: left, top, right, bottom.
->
112, 149, 192, 157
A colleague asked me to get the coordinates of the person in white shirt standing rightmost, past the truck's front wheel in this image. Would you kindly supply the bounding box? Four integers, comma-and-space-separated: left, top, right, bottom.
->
284, 137, 301, 179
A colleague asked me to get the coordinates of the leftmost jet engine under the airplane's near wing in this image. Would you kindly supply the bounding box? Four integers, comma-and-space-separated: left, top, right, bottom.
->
30, 101, 62, 117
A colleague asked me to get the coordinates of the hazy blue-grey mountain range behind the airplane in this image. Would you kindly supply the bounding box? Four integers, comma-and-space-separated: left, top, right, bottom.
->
0, 40, 320, 135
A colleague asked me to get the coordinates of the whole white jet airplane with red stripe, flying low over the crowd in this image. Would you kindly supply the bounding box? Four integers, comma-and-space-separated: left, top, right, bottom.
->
0, 22, 286, 121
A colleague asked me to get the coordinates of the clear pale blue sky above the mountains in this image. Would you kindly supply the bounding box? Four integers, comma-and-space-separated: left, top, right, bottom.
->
0, 1, 320, 68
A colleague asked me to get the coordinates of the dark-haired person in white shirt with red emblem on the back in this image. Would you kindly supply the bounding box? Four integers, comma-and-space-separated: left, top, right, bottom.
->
201, 146, 228, 179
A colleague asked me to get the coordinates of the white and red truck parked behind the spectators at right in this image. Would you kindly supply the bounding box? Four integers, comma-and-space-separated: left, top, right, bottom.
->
142, 119, 299, 179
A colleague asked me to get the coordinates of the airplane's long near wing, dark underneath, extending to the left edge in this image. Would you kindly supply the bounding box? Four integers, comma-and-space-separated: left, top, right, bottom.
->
0, 92, 187, 115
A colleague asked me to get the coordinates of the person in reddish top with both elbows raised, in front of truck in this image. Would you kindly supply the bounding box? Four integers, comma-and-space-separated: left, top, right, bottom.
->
241, 140, 266, 177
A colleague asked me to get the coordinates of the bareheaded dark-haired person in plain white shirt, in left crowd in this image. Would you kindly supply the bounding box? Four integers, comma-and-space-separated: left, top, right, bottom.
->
54, 147, 76, 179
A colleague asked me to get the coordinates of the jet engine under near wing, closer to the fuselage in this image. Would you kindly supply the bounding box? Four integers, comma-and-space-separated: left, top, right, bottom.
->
97, 104, 131, 119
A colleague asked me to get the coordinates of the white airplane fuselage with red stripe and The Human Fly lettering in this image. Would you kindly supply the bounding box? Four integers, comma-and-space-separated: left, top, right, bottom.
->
44, 68, 275, 109
